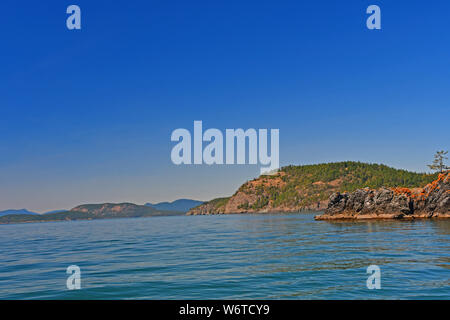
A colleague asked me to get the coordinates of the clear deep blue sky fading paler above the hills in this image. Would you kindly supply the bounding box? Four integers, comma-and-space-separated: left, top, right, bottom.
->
0, 0, 450, 211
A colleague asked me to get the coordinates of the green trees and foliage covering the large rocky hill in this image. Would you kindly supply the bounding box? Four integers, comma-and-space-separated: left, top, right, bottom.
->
248, 161, 437, 210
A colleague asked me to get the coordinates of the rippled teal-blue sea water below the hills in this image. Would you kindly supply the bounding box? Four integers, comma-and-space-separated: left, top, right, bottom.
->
0, 214, 450, 299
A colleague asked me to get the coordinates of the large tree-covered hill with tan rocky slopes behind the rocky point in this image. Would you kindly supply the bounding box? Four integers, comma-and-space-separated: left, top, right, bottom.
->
187, 162, 436, 215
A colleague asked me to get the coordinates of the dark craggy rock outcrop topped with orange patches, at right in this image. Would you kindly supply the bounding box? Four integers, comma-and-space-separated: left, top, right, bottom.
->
316, 171, 450, 220
